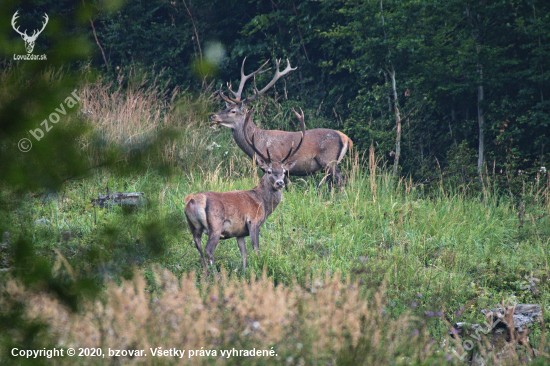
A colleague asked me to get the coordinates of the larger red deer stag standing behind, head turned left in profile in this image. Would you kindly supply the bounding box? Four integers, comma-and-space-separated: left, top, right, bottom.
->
212, 58, 353, 187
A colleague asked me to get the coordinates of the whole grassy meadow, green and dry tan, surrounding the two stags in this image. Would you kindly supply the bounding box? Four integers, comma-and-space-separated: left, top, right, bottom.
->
0, 75, 550, 365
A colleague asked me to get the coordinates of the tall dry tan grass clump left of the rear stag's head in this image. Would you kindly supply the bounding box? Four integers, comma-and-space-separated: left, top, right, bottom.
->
75, 75, 226, 170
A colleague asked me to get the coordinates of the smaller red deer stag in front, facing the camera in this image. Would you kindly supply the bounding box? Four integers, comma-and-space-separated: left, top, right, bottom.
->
185, 110, 309, 270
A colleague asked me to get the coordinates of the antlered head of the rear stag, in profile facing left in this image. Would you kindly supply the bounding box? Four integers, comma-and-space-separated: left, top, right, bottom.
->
212, 57, 296, 129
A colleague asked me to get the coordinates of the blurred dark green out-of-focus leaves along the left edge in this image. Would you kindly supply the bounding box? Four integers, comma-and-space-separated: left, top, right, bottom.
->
0, 1, 184, 363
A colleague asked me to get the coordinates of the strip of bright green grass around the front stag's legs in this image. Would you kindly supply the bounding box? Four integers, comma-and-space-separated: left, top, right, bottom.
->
4, 135, 549, 334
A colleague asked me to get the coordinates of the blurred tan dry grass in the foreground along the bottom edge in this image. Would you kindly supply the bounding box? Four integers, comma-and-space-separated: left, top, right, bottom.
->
0, 271, 444, 365
